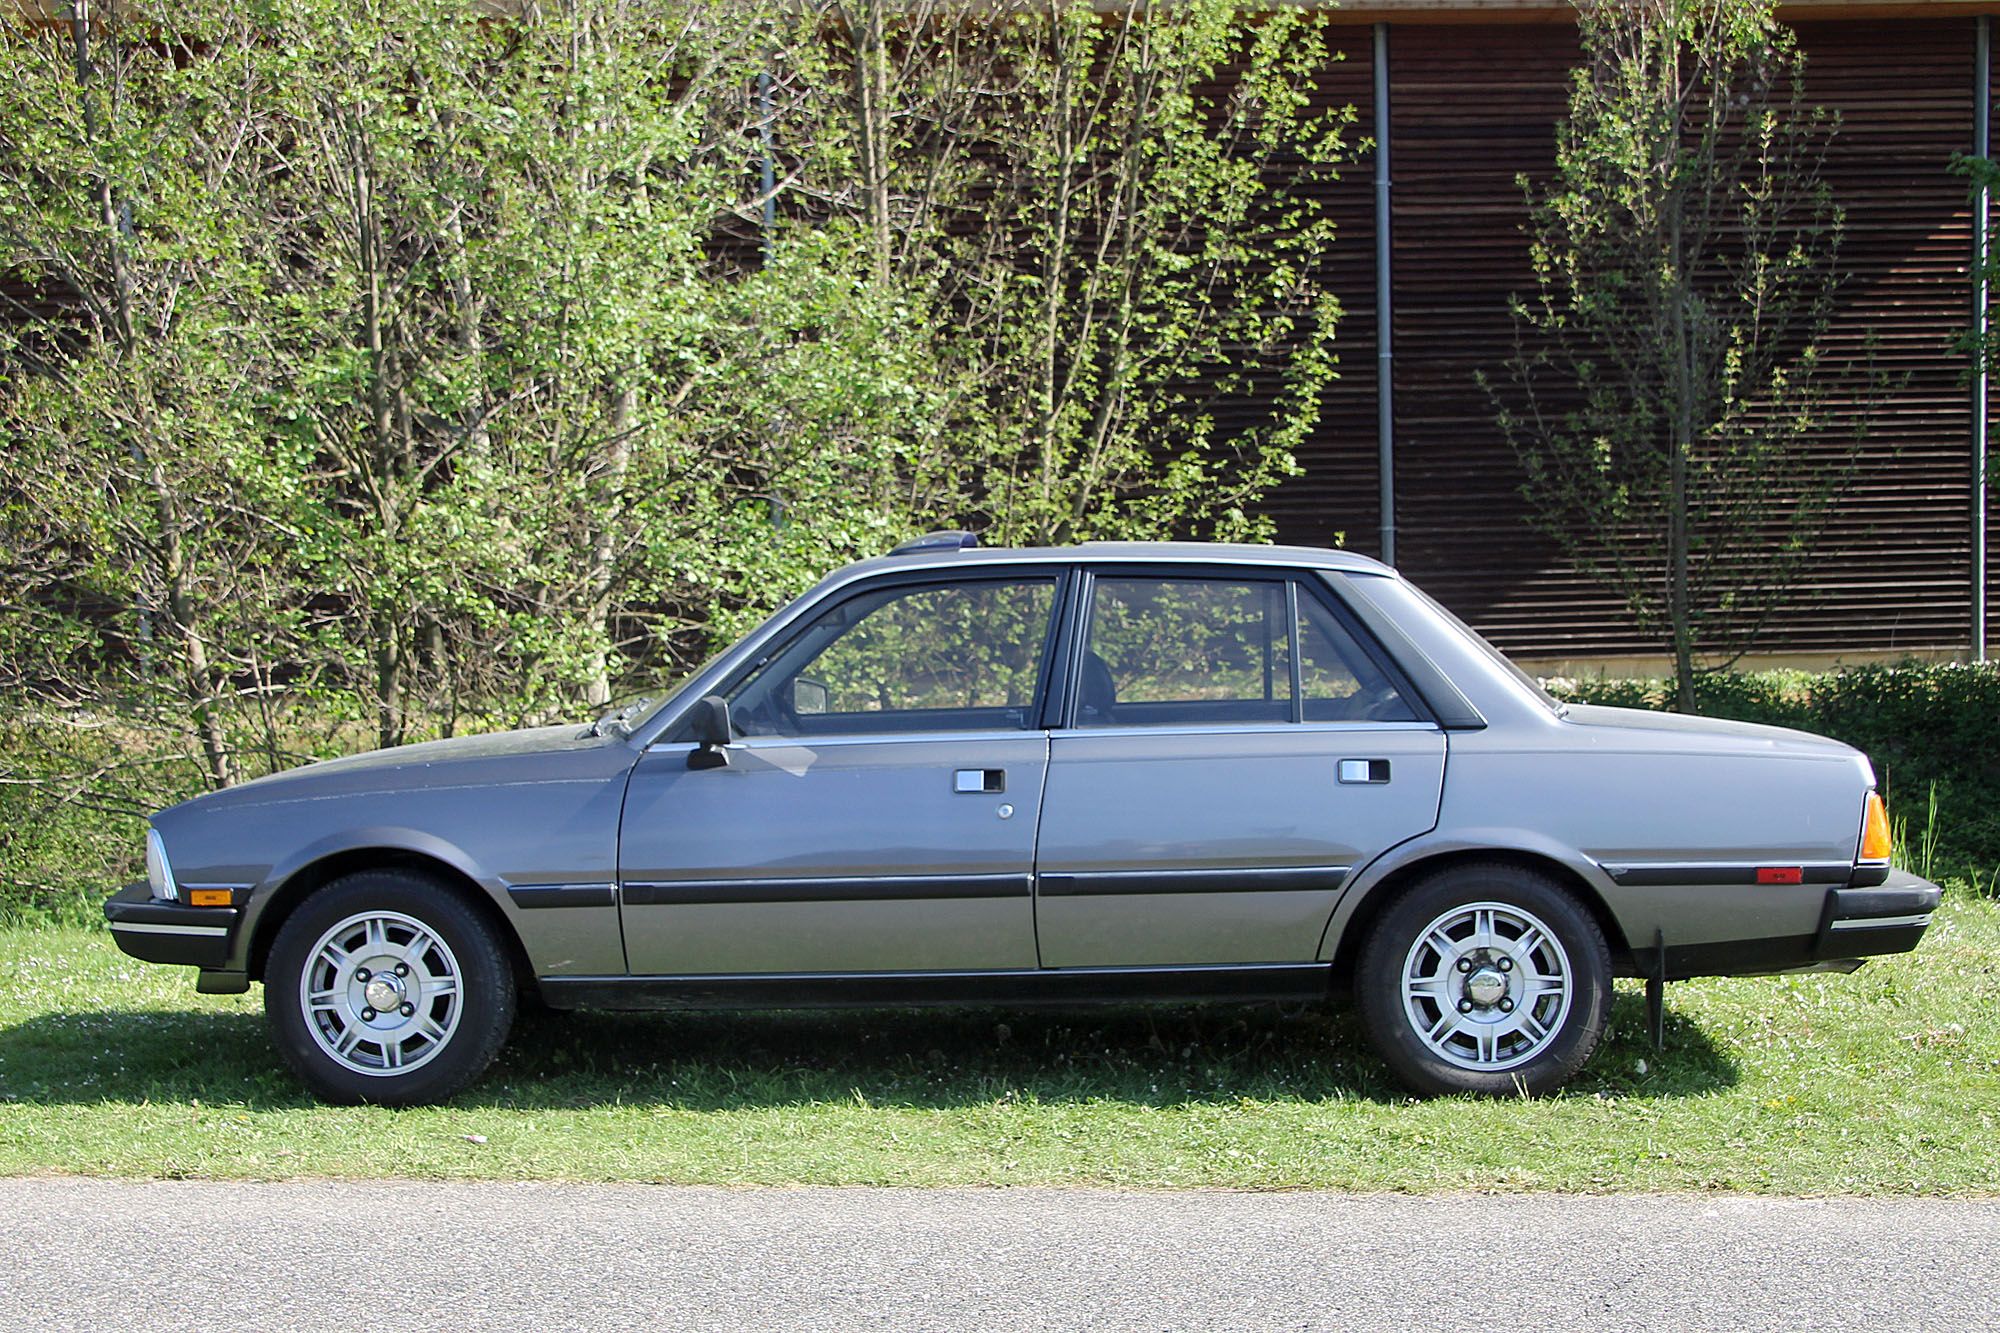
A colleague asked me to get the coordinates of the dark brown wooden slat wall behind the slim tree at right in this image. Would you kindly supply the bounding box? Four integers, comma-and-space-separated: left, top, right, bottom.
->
1270, 10, 2000, 656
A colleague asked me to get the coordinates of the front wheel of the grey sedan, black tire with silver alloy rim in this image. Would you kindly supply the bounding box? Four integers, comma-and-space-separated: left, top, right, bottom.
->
264, 871, 514, 1107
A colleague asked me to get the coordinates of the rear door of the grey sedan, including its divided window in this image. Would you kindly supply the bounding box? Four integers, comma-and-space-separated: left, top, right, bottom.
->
1036, 568, 1444, 967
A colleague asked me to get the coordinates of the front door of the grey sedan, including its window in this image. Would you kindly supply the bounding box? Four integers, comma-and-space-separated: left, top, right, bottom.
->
620, 572, 1058, 975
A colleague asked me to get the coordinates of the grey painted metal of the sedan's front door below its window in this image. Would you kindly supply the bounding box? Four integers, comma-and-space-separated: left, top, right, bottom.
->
620, 733, 1048, 975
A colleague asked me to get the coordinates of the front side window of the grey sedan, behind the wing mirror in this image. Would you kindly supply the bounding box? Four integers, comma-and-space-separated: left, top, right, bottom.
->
728, 578, 1056, 737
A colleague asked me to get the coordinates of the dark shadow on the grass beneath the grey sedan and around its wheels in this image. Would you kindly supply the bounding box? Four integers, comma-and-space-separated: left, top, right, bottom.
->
0, 980, 1738, 1113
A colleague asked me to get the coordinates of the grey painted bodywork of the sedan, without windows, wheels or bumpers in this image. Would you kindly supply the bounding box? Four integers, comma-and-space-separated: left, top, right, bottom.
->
121, 544, 1920, 1000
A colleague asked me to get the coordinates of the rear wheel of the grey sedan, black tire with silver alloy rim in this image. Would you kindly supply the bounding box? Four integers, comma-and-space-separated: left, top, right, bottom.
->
1354, 863, 1612, 1097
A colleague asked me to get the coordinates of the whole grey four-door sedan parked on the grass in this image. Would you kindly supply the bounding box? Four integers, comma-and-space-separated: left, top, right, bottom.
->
106, 534, 1938, 1105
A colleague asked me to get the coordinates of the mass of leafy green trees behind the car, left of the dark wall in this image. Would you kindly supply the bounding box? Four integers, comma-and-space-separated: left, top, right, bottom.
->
0, 0, 1344, 803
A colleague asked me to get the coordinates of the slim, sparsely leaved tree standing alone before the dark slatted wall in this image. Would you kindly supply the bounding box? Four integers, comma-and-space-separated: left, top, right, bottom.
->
1496, 0, 1854, 713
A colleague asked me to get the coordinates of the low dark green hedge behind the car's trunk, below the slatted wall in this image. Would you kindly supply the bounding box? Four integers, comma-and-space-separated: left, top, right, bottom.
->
1546, 662, 2000, 891
